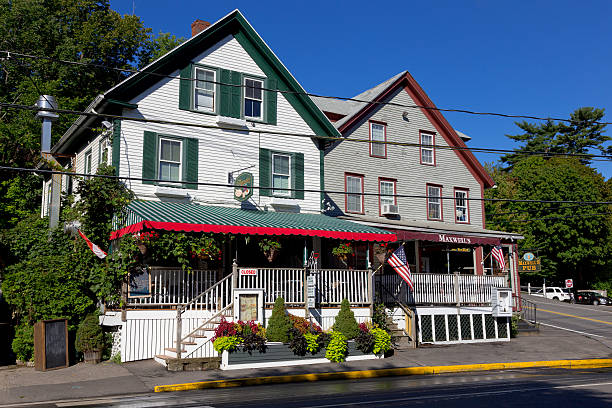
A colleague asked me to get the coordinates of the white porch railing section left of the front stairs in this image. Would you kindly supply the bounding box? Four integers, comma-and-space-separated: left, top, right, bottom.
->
128, 267, 220, 306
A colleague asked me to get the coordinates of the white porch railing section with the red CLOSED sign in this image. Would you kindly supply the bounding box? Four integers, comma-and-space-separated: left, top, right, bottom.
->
238, 268, 306, 304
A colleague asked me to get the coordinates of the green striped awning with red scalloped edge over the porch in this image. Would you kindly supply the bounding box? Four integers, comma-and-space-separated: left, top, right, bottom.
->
110, 201, 396, 242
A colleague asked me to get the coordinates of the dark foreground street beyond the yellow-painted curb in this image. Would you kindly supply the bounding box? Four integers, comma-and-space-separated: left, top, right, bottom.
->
16, 369, 612, 408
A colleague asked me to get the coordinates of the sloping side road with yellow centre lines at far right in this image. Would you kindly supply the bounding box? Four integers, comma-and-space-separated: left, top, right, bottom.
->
523, 294, 612, 342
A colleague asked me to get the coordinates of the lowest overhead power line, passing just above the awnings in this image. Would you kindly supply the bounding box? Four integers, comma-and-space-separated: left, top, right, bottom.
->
0, 166, 612, 205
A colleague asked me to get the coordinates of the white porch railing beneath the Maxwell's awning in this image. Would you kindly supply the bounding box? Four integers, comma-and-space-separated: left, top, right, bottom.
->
376, 273, 507, 305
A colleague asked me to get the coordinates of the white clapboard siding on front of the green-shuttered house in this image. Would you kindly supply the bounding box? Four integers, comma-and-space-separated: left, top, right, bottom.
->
120, 37, 320, 212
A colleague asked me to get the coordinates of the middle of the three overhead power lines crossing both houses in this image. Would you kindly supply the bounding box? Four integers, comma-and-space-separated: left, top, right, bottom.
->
0, 102, 612, 161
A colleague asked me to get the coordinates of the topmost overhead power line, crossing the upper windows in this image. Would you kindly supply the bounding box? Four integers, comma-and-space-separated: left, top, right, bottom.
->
0, 51, 612, 125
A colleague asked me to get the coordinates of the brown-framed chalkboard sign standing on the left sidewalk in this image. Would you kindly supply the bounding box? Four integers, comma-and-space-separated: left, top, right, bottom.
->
34, 319, 68, 371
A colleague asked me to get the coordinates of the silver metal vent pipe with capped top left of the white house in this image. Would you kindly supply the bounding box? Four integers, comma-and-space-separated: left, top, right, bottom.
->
36, 95, 62, 230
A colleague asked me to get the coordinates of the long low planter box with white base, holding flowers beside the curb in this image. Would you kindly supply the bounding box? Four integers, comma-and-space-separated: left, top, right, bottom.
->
221, 341, 383, 370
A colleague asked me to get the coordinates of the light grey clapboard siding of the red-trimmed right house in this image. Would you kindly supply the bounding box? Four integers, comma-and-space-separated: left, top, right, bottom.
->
325, 89, 482, 227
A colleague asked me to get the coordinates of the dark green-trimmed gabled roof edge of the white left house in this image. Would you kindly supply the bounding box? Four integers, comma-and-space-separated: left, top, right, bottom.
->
51, 10, 340, 153
